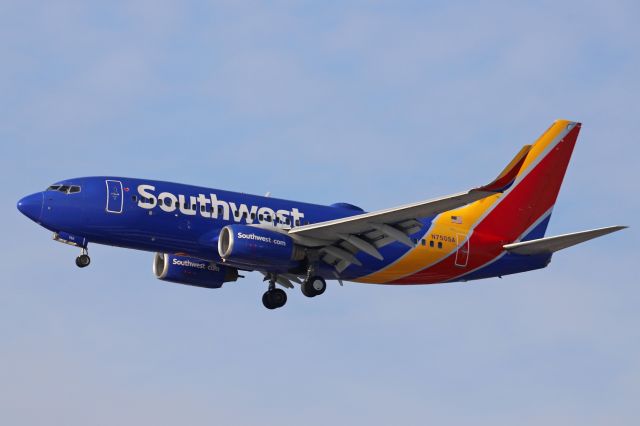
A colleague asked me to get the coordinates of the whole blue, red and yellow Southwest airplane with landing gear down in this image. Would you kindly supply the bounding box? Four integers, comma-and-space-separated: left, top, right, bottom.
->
17, 120, 626, 309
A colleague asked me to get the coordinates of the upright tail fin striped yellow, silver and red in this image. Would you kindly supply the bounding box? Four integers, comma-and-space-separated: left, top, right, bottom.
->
476, 120, 580, 242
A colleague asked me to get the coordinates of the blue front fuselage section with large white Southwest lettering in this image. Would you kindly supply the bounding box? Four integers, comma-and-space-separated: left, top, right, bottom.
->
21, 177, 424, 278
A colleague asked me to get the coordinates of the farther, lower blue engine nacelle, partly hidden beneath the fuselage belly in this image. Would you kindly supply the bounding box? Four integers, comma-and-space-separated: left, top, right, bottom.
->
153, 253, 238, 288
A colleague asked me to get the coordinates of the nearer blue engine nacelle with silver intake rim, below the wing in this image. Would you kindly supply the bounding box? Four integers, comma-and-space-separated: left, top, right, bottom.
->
218, 225, 305, 266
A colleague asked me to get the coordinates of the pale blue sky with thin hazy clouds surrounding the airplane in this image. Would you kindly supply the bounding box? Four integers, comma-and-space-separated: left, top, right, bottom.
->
0, 1, 640, 425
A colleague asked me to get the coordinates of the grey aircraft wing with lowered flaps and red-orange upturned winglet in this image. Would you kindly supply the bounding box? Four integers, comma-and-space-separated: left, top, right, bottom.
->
288, 145, 531, 271
